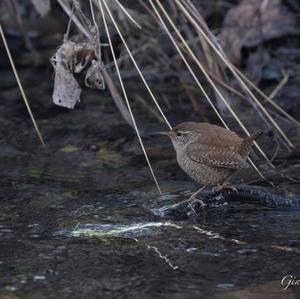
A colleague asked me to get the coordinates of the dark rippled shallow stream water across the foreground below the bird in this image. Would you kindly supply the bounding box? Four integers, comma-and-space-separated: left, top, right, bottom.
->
0, 175, 300, 298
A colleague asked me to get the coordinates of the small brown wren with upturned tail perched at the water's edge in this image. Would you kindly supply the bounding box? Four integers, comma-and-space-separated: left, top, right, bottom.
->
161, 122, 262, 204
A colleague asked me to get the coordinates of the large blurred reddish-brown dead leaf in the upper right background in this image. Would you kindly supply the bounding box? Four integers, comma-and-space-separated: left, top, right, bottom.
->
221, 0, 300, 64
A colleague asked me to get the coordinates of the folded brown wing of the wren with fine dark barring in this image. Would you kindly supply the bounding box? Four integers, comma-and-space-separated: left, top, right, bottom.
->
187, 142, 249, 169
